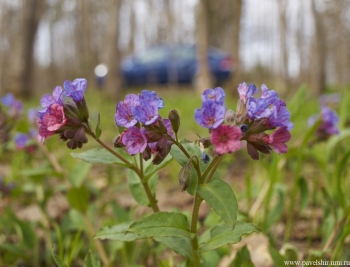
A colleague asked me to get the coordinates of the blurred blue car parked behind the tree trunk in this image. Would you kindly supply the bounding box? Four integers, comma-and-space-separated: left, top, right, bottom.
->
121, 45, 233, 86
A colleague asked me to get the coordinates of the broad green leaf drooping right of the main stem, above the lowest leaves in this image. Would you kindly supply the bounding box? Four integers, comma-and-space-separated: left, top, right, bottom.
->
197, 180, 238, 229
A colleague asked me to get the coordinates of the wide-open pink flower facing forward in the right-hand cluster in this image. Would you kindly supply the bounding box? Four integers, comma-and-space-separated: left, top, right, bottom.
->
210, 124, 242, 155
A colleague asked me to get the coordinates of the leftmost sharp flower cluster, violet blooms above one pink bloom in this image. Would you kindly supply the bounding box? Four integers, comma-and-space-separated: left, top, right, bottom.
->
37, 79, 89, 149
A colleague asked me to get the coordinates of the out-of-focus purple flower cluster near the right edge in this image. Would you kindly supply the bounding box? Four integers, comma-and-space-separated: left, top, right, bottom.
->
308, 96, 339, 141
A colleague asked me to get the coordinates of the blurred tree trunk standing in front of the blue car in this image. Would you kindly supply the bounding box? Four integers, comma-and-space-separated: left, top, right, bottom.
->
196, 0, 211, 93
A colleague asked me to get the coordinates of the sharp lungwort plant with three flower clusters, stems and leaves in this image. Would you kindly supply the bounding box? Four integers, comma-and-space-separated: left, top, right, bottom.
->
37, 79, 293, 266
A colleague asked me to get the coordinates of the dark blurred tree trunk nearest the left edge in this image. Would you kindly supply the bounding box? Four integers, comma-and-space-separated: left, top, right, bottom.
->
20, 0, 45, 97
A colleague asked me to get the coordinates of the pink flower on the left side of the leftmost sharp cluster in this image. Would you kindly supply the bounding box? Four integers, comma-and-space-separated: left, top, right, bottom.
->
36, 103, 67, 143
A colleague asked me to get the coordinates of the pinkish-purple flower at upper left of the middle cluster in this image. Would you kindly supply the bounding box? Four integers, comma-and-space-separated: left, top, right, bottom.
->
114, 94, 140, 128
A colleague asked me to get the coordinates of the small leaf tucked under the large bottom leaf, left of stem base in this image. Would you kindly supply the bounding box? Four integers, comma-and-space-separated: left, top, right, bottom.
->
154, 239, 192, 259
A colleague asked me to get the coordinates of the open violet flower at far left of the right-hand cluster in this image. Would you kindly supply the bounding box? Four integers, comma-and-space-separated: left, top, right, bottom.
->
194, 101, 225, 129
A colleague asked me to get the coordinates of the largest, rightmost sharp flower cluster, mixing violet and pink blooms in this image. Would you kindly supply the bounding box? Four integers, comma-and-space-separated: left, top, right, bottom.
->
194, 83, 293, 160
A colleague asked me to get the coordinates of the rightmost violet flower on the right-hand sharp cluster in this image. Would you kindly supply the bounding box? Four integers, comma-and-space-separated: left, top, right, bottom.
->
268, 99, 294, 131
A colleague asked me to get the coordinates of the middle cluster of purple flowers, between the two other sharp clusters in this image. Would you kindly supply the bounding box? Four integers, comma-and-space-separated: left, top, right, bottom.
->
114, 90, 178, 164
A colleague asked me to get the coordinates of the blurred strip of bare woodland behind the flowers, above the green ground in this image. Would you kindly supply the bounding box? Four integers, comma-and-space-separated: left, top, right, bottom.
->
0, 0, 350, 98
